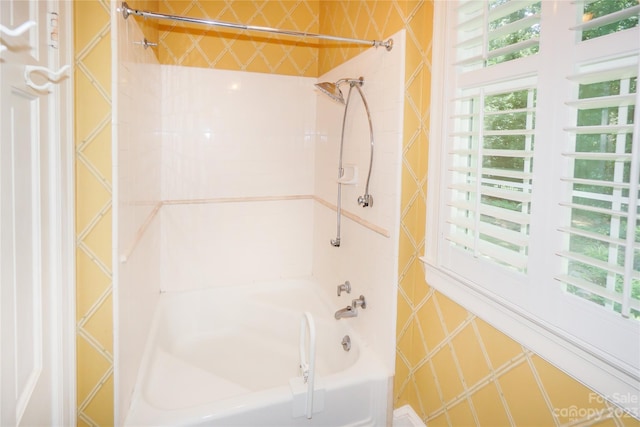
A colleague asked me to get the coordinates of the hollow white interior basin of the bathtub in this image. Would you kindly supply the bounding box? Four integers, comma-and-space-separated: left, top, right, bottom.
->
149, 281, 360, 398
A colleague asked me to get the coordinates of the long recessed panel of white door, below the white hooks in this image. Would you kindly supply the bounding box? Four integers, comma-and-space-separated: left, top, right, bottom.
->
11, 85, 43, 419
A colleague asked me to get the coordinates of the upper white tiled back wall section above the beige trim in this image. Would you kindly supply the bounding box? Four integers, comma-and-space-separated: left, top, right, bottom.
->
161, 66, 316, 200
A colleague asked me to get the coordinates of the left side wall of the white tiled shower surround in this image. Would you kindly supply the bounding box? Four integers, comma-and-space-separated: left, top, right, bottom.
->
111, 10, 162, 425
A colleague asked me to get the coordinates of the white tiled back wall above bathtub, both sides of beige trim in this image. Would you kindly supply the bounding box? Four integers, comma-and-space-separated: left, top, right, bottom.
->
161, 66, 316, 291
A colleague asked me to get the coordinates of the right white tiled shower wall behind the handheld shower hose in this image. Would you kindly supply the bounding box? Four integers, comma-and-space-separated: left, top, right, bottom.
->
313, 30, 405, 373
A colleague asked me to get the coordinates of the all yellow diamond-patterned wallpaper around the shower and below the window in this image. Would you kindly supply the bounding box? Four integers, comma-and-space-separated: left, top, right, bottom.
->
74, 0, 640, 427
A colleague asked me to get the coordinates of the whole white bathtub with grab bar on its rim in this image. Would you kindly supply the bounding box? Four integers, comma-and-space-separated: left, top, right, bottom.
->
125, 280, 390, 427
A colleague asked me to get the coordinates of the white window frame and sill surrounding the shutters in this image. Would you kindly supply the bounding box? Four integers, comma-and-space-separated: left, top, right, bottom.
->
421, 0, 640, 417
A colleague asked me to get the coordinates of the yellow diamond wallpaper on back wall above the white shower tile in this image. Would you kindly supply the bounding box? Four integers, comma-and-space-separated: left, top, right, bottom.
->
158, 0, 318, 77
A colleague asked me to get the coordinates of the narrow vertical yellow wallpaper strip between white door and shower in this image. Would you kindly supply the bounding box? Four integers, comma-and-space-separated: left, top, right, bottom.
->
74, 1, 113, 426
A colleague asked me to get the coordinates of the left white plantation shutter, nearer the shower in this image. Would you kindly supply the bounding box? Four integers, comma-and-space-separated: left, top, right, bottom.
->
446, 0, 541, 272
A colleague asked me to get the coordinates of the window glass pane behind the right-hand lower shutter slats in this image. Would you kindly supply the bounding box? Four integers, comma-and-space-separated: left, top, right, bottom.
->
565, 67, 640, 318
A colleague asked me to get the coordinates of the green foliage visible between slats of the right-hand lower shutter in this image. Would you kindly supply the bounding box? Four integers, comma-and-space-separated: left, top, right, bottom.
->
567, 77, 640, 318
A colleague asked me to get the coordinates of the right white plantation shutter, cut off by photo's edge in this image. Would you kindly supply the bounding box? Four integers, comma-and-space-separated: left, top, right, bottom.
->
557, 0, 640, 317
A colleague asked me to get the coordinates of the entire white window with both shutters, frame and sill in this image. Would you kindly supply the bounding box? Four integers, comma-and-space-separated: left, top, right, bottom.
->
422, 0, 640, 414
